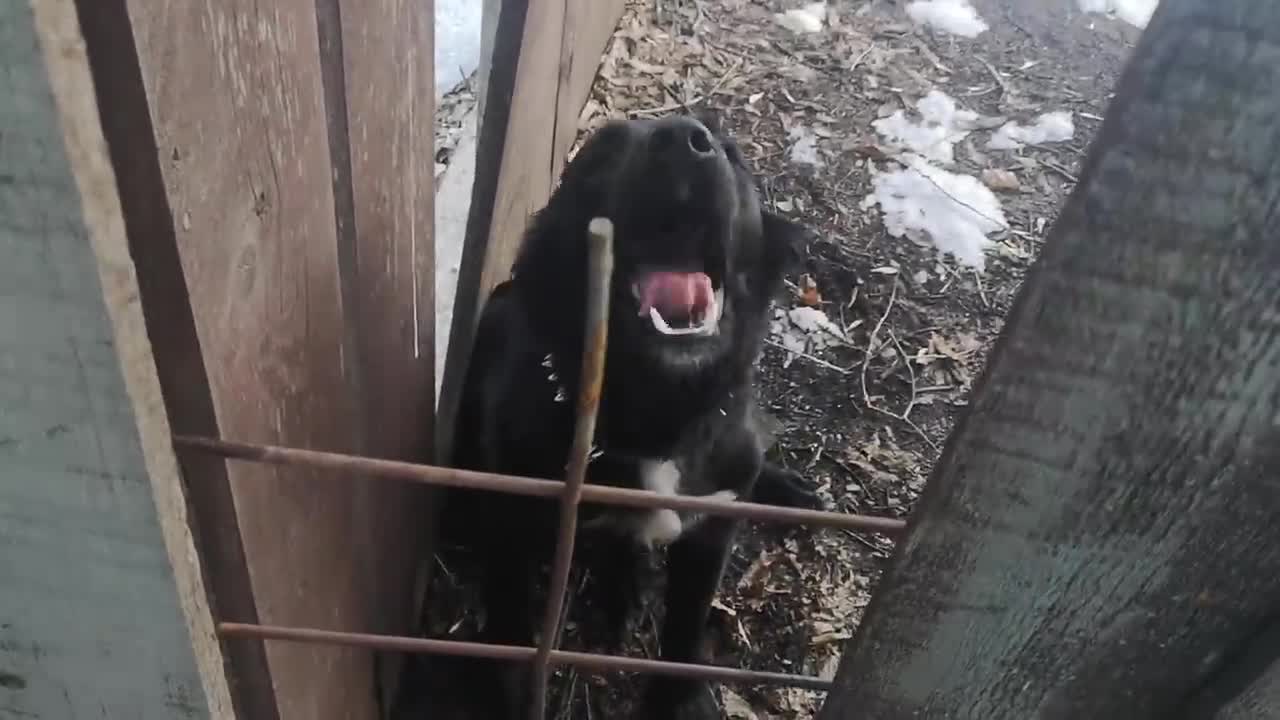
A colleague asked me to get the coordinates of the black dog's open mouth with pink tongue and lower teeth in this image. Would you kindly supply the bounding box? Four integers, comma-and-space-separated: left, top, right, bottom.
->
631, 270, 724, 336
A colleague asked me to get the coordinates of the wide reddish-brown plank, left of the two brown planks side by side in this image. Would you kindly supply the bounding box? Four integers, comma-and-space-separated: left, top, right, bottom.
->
120, 0, 376, 720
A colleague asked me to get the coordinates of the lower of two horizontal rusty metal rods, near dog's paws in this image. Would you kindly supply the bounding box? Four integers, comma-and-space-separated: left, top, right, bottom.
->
218, 623, 831, 691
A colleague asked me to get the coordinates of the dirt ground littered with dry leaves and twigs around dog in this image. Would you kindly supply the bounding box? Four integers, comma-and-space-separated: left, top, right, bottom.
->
433, 0, 1138, 720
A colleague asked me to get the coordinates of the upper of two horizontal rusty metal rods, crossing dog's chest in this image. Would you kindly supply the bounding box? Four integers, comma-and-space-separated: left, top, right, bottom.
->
173, 436, 906, 534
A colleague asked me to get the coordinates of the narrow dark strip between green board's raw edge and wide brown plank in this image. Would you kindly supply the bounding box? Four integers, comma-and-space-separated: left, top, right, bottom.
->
76, 0, 279, 720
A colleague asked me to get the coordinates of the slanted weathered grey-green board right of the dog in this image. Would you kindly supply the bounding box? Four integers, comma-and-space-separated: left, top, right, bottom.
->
819, 0, 1280, 720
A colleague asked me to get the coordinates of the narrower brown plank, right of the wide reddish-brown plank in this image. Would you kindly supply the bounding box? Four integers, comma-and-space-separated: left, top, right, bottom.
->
321, 0, 435, 703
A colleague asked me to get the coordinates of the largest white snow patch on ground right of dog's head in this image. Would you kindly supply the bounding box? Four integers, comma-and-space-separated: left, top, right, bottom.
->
863, 156, 1009, 270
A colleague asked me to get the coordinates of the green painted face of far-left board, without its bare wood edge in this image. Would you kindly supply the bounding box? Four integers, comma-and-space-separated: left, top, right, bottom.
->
0, 0, 210, 720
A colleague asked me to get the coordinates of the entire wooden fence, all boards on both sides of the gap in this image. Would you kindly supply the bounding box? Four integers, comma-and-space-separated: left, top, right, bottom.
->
0, 0, 1280, 720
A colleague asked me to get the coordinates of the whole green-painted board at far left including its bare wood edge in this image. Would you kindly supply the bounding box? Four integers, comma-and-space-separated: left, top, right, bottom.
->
0, 1, 233, 720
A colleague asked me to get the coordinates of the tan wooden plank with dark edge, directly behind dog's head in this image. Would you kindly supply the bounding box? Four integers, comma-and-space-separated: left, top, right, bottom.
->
436, 0, 623, 458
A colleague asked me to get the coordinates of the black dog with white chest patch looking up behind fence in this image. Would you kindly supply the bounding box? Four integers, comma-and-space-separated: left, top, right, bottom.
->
447, 117, 815, 720
